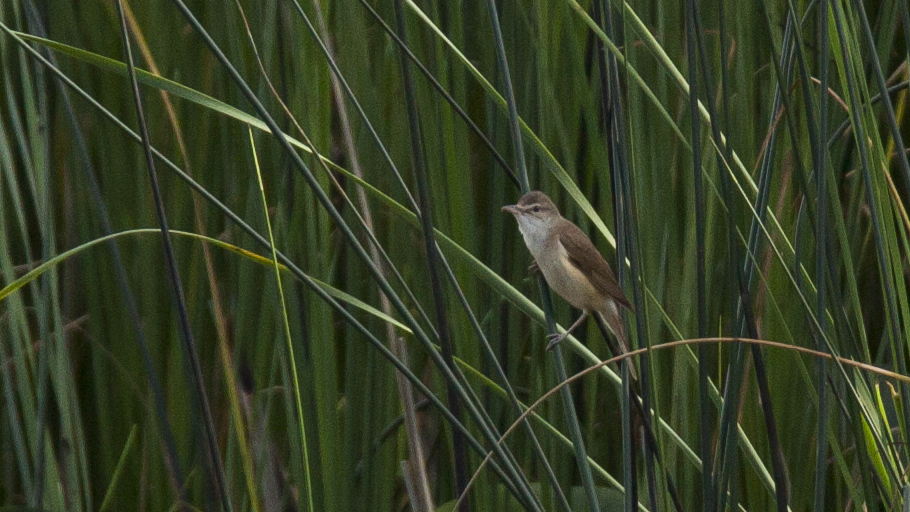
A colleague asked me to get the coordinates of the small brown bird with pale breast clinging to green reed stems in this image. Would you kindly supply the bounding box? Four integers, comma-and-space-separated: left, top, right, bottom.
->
502, 190, 632, 353
